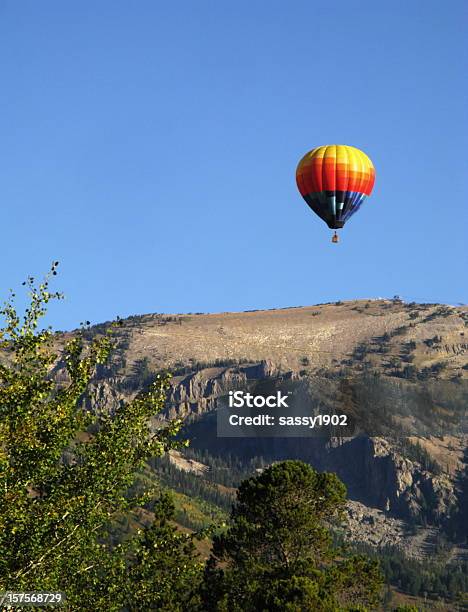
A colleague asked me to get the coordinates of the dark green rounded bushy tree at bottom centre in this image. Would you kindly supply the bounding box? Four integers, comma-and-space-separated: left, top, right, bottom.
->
202, 461, 382, 612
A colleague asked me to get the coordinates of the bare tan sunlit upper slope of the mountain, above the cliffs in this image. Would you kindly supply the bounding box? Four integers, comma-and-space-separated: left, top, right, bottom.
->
81, 300, 468, 378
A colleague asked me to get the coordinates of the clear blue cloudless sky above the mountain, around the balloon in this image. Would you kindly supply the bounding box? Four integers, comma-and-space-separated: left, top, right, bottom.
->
0, 0, 468, 329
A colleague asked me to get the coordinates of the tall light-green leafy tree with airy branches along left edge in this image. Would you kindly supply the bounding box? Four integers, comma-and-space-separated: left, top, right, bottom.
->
0, 262, 199, 610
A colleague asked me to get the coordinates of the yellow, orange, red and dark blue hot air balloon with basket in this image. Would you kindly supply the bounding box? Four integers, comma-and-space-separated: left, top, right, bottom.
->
296, 145, 375, 242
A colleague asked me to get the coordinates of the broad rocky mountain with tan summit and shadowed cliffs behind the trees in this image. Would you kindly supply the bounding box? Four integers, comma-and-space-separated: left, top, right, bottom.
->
63, 298, 468, 559
